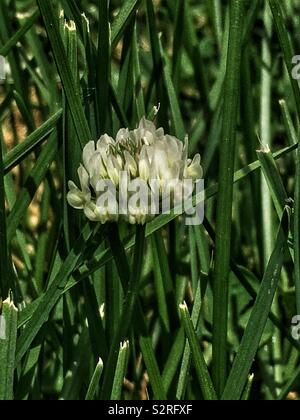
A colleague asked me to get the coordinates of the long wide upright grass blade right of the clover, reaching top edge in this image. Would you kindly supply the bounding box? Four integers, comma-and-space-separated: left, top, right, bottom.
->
213, 0, 244, 396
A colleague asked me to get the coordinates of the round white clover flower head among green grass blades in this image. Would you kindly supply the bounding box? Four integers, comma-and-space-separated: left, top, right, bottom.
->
67, 118, 203, 224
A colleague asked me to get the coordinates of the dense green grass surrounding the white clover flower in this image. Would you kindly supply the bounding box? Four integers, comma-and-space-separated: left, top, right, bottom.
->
0, 0, 300, 400
